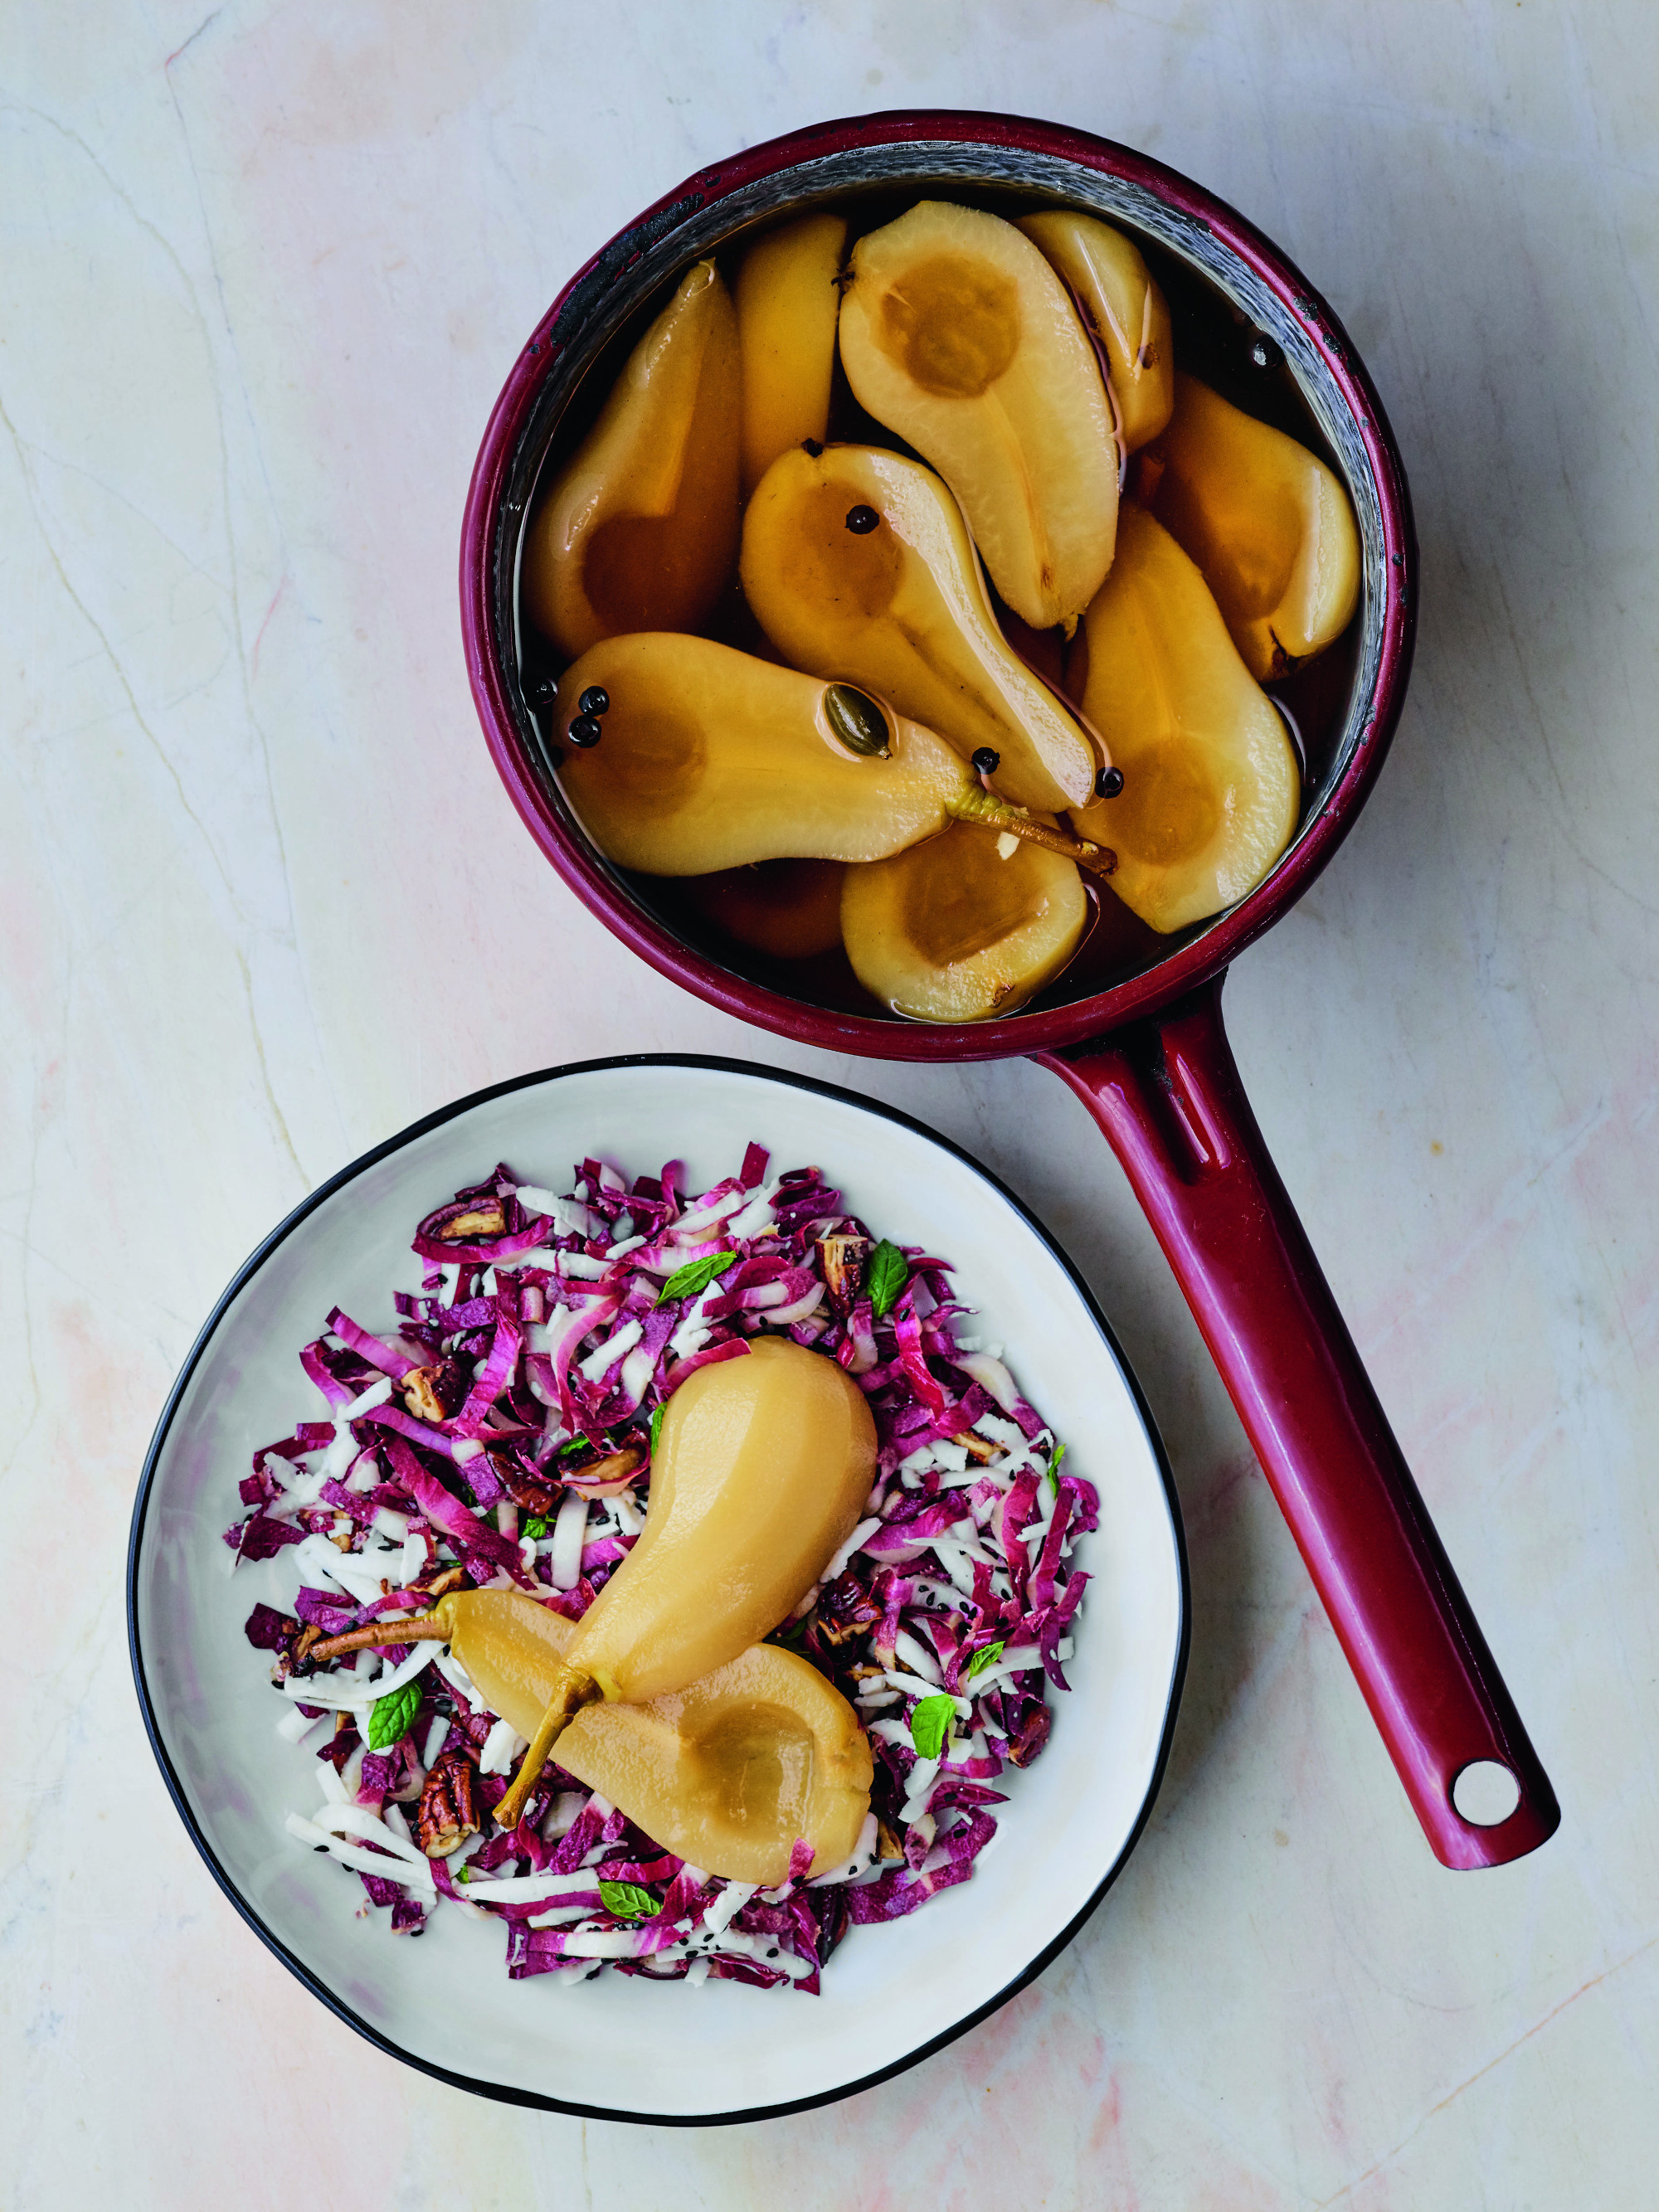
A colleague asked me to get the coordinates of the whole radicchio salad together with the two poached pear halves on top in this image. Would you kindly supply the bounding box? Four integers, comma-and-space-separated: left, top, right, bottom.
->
228, 1146, 1097, 1989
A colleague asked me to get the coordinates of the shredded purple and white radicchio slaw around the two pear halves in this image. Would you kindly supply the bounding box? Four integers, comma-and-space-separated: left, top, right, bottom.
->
226, 1144, 1099, 1993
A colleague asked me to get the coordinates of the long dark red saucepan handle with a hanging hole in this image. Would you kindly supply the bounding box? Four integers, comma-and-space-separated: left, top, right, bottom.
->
1035, 978, 1562, 1867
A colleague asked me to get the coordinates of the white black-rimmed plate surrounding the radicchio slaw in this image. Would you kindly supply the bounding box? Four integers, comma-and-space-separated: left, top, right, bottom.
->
129, 1057, 1188, 2123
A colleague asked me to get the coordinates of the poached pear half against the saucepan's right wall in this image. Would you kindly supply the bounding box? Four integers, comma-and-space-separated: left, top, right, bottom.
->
1152, 376, 1360, 683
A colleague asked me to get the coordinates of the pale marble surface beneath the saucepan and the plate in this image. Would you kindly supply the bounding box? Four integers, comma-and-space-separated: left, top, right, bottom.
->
0, 0, 1659, 2212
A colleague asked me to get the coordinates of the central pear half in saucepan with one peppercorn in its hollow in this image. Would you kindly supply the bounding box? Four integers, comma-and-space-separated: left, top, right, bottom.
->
739, 445, 1104, 807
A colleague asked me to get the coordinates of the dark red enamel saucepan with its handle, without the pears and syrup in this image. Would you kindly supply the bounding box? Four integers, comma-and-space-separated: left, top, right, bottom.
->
460, 113, 1559, 1867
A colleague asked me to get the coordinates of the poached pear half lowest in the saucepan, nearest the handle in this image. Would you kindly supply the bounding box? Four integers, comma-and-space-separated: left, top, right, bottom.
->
840, 823, 1088, 1022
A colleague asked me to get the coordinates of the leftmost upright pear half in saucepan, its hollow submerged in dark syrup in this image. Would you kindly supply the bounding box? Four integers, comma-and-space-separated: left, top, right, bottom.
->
524, 261, 741, 654
